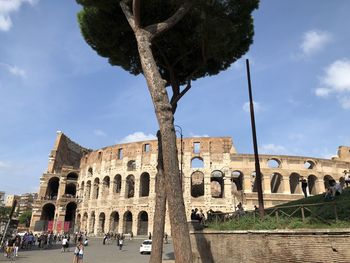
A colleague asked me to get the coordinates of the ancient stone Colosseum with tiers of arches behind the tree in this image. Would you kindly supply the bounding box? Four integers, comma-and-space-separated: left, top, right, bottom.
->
31, 132, 350, 235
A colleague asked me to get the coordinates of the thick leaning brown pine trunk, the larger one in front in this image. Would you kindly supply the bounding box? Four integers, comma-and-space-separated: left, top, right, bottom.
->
135, 29, 192, 263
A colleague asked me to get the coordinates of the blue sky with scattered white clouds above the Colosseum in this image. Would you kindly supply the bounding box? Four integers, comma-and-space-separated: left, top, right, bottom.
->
0, 0, 350, 194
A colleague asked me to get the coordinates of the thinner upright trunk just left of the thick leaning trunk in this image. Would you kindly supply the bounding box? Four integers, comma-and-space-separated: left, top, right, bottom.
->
149, 131, 166, 263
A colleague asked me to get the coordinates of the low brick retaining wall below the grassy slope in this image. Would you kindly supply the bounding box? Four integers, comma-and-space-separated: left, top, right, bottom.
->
191, 229, 350, 263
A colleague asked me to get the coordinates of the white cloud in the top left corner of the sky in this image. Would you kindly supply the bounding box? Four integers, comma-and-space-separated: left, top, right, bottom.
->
0, 0, 38, 31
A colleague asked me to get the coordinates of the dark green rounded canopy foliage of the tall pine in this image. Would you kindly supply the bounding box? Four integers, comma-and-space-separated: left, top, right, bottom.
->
77, 0, 258, 85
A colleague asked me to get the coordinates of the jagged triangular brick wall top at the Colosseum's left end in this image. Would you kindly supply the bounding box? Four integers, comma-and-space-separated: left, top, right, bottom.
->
47, 131, 91, 173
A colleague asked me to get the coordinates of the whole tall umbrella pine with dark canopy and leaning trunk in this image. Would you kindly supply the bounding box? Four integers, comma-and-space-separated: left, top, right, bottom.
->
77, 0, 258, 262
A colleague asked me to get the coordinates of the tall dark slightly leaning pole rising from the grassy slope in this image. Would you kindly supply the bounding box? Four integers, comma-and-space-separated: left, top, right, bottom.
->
246, 59, 264, 217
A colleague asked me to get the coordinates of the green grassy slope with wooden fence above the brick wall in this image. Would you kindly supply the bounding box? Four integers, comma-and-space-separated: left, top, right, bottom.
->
208, 189, 350, 230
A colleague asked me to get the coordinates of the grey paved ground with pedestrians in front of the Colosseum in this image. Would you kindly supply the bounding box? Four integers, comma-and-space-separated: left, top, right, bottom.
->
0, 238, 174, 263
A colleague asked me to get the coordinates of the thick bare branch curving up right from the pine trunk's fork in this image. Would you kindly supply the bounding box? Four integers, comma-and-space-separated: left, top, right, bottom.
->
145, 0, 194, 37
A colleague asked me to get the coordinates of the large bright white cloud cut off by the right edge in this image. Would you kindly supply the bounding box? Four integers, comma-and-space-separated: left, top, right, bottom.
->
315, 59, 350, 110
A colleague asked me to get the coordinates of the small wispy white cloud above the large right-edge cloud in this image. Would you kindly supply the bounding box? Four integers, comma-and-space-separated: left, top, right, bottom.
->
300, 30, 332, 56
